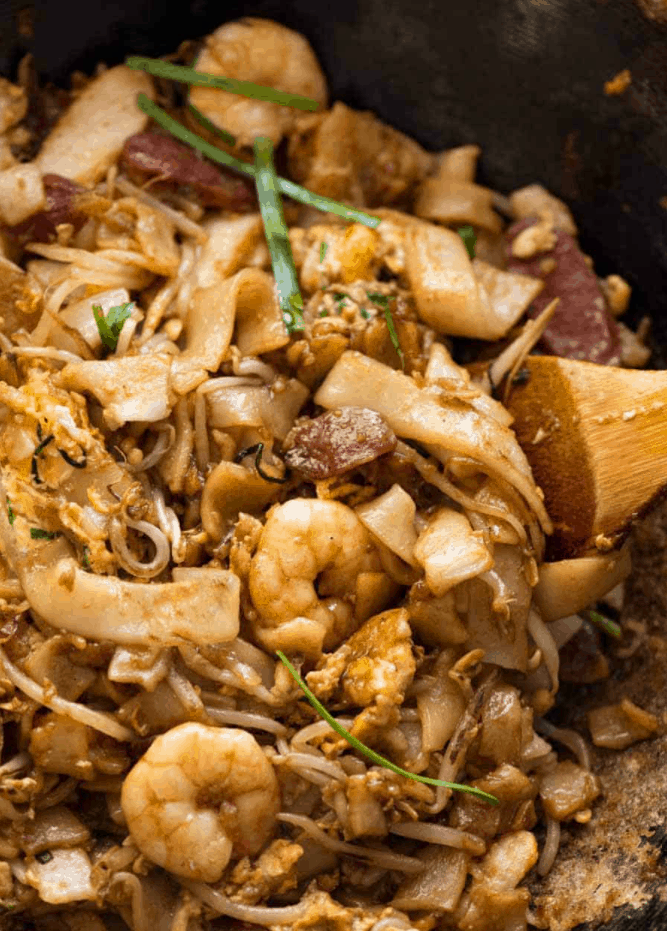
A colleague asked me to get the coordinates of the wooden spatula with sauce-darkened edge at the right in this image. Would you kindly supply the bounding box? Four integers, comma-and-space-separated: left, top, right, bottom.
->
506, 356, 667, 558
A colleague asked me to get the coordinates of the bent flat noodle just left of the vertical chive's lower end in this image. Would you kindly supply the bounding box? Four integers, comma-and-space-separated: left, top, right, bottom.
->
172, 268, 276, 395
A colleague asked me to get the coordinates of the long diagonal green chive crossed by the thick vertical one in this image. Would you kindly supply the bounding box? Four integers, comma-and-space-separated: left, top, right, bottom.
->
137, 94, 380, 229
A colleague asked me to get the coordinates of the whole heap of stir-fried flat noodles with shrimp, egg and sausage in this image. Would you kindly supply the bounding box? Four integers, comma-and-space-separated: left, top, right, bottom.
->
0, 19, 655, 931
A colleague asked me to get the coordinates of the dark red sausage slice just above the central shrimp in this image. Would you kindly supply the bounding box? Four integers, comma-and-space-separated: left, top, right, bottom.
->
285, 407, 396, 481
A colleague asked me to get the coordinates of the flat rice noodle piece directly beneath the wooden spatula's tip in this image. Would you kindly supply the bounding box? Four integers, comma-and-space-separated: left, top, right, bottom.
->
533, 545, 632, 623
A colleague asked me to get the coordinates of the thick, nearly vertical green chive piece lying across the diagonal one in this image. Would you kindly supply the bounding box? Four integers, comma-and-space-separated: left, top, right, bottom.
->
253, 136, 303, 333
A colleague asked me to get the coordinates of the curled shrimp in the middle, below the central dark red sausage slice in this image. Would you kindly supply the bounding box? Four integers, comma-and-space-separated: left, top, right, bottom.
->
248, 498, 385, 654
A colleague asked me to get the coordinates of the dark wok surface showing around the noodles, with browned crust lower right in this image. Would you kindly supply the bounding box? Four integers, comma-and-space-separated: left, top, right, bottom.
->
0, 0, 667, 931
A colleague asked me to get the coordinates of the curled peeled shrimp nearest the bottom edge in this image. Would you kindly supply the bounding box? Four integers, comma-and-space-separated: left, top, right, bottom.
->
121, 723, 280, 882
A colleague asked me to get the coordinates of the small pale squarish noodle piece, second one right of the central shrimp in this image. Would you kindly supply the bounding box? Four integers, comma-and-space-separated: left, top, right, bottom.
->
414, 508, 493, 597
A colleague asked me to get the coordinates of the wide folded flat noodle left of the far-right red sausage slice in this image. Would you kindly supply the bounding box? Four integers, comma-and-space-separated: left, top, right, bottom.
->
404, 223, 511, 340
